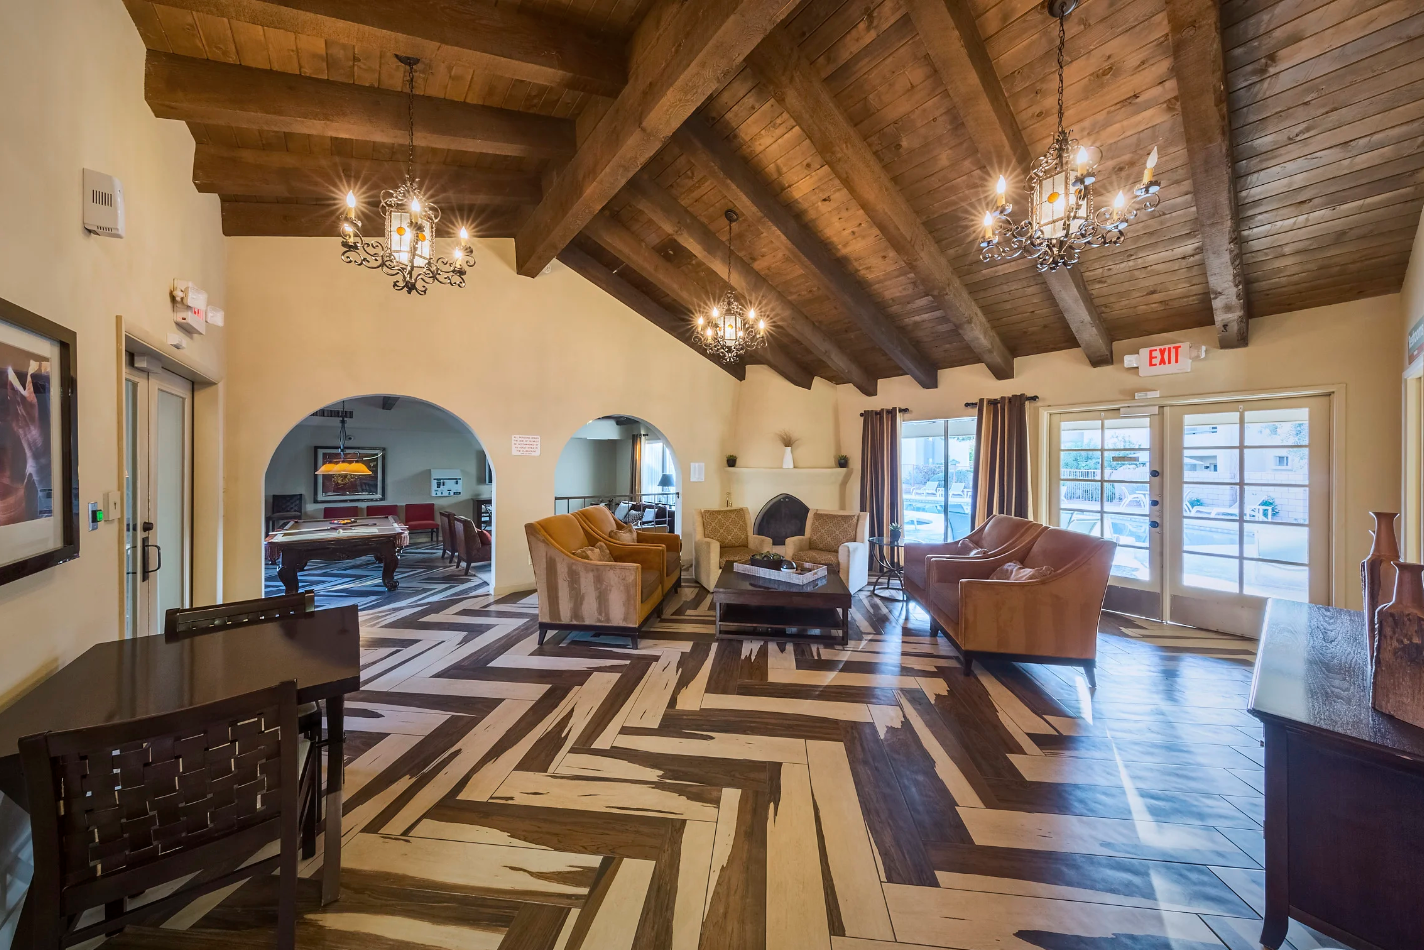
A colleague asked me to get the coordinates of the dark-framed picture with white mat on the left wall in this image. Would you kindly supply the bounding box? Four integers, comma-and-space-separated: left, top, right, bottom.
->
0, 293, 80, 584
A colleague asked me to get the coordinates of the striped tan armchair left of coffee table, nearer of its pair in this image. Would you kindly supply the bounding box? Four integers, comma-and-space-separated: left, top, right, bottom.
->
524, 514, 666, 649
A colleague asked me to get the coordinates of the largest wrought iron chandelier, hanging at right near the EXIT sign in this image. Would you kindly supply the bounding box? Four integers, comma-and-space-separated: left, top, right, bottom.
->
980, 0, 1159, 271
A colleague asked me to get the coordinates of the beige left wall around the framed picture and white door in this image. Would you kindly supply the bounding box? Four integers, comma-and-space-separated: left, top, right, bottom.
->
0, 0, 224, 705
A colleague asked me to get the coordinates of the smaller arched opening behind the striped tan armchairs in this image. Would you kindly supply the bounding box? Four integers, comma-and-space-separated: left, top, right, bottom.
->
554, 416, 682, 531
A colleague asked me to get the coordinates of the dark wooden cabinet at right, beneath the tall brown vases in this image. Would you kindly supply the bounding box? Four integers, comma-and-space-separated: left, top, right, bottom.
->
1250, 600, 1424, 950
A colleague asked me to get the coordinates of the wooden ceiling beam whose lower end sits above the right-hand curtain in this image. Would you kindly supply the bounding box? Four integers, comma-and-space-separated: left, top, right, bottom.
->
748, 30, 1014, 379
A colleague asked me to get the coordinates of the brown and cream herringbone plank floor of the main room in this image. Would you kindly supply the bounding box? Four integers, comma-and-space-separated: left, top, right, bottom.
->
111, 578, 1337, 950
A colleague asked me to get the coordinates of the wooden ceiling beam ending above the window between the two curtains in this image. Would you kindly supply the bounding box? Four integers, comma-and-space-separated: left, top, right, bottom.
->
672, 115, 940, 389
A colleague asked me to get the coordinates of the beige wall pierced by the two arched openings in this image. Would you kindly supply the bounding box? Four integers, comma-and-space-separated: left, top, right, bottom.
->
224, 238, 738, 600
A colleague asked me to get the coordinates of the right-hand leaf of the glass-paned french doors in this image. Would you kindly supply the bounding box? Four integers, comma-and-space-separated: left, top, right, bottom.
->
1165, 396, 1331, 637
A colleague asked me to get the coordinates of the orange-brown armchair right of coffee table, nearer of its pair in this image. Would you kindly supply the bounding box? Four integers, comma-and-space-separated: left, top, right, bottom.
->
920, 528, 1118, 685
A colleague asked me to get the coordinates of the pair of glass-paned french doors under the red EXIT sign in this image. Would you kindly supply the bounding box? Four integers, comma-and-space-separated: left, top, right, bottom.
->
1051, 396, 1331, 637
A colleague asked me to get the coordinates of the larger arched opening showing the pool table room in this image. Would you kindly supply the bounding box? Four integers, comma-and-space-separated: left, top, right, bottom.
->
263, 395, 494, 608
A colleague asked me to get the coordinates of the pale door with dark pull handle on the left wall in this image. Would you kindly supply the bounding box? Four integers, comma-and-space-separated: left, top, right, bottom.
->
124, 360, 192, 637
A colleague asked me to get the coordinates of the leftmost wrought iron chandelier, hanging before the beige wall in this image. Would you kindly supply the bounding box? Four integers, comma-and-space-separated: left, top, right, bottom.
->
340, 56, 474, 296
